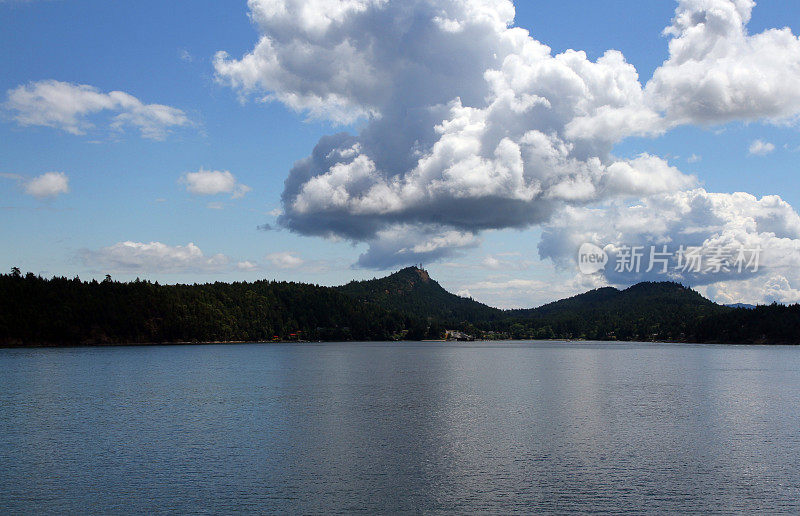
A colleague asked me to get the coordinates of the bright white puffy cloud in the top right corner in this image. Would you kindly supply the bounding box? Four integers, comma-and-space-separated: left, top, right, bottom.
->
646, 0, 800, 124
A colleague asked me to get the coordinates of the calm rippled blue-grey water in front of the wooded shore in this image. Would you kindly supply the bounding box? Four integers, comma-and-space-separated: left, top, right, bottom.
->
0, 342, 800, 514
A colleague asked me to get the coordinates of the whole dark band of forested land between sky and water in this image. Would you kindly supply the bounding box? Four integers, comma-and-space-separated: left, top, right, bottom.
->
0, 267, 800, 346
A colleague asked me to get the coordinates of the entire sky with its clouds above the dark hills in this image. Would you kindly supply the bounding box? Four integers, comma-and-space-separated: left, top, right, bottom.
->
0, 0, 800, 308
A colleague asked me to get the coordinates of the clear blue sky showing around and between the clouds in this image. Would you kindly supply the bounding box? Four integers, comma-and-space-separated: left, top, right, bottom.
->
0, 0, 800, 307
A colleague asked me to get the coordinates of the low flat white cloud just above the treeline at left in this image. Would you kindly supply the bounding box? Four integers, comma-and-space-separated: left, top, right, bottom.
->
80, 241, 230, 273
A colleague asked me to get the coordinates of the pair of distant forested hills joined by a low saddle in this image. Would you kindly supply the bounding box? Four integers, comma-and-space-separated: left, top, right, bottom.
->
337, 267, 731, 341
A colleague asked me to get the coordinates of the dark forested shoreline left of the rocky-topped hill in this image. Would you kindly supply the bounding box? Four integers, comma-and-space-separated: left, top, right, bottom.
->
0, 273, 412, 345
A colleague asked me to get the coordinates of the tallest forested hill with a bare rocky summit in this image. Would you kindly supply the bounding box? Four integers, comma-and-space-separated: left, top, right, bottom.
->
336, 267, 505, 326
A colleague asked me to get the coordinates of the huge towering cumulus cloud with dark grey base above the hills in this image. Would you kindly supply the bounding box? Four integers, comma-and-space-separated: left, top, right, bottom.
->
216, 0, 680, 267
